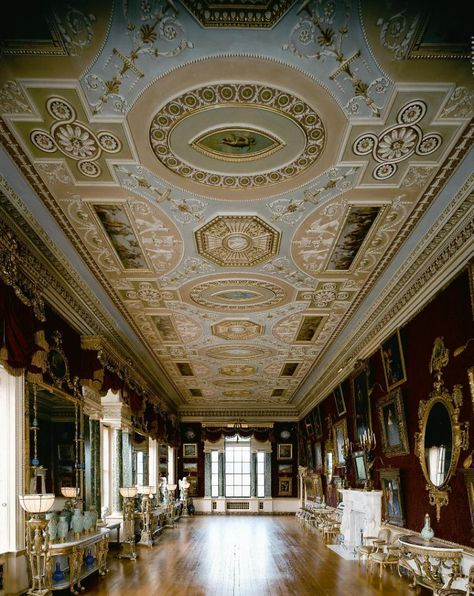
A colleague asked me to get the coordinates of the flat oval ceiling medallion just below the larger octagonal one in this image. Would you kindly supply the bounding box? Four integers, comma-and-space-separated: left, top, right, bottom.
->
189, 279, 286, 312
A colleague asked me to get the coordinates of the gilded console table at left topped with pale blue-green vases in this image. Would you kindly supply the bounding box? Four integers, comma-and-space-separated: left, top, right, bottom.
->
49, 528, 110, 594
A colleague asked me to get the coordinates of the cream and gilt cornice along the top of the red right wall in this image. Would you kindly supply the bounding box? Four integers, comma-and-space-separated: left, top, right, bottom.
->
300, 175, 474, 415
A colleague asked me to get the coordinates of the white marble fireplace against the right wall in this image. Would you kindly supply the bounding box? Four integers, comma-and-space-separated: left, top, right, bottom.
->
339, 489, 382, 549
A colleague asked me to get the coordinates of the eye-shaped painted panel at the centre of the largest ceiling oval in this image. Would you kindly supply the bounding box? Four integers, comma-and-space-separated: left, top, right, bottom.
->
191, 127, 284, 162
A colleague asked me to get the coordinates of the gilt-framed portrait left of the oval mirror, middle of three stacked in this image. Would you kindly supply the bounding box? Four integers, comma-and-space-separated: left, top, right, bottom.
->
377, 388, 410, 457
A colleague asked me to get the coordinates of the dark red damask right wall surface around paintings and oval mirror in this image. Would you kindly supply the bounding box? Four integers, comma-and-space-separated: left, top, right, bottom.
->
300, 270, 474, 546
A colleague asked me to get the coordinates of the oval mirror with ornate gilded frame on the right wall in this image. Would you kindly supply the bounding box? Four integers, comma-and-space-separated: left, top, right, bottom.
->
415, 338, 468, 521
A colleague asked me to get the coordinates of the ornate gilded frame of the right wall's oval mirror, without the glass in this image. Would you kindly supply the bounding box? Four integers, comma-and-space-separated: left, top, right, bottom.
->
415, 338, 469, 521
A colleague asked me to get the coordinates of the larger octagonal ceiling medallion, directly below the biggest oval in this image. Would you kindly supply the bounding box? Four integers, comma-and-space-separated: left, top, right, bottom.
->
195, 215, 280, 267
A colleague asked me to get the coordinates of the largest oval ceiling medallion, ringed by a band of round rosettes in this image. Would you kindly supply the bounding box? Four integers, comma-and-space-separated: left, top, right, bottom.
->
149, 83, 326, 189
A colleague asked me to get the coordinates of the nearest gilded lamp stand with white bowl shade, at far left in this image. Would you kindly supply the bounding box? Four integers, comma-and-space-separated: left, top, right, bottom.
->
18, 493, 54, 596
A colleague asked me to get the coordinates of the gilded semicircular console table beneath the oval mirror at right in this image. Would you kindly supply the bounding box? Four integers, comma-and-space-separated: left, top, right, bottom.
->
398, 534, 463, 591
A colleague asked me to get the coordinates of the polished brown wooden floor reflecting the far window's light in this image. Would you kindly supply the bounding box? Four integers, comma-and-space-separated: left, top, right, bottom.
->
84, 516, 428, 596
